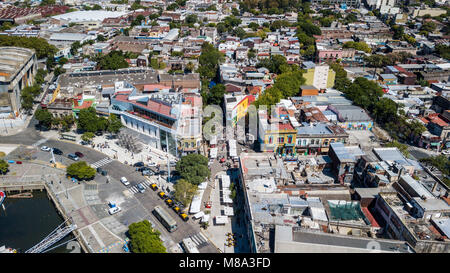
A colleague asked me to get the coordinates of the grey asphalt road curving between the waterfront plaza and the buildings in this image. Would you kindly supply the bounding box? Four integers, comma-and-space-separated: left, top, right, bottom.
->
0, 124, 218, 253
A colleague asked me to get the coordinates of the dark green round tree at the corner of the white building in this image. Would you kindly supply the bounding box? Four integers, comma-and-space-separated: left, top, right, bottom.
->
175, 154, 211, 185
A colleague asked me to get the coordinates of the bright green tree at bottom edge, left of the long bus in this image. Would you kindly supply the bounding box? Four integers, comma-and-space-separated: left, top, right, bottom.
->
128, 220, 166, 253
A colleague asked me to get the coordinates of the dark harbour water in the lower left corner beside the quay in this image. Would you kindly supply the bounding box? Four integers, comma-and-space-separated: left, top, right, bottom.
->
0, 191, 74, 253
